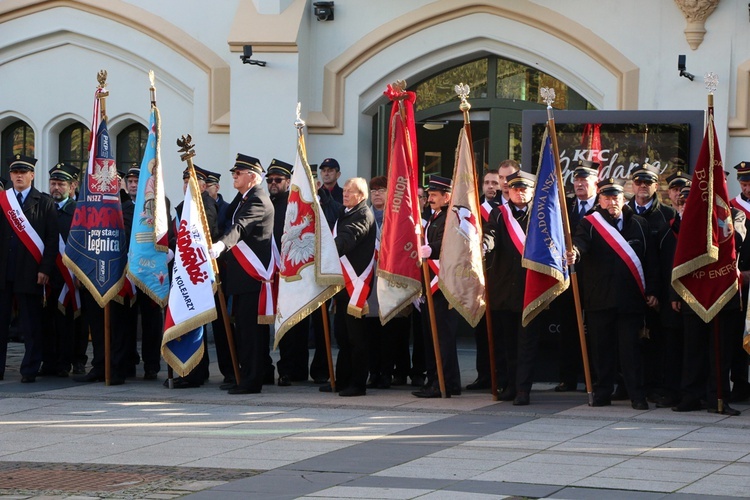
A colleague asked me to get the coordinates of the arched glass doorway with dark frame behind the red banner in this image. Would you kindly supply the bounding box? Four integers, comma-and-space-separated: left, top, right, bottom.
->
372, 55, 595, 182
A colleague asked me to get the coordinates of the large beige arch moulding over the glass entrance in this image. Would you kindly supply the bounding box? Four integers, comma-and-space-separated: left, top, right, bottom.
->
307, 0, 639, 134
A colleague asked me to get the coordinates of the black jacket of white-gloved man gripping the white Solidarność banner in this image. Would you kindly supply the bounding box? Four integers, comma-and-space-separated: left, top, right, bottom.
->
219, 186, 273, 295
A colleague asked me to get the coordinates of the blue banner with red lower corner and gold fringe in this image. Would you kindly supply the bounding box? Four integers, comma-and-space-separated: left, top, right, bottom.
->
521, 137, 570, 326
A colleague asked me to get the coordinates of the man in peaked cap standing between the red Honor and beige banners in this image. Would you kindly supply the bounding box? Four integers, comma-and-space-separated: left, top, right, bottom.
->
412, 175, 461, 398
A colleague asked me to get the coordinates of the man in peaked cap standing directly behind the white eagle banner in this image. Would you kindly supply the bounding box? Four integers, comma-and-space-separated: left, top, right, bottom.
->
266, 158, 310, 387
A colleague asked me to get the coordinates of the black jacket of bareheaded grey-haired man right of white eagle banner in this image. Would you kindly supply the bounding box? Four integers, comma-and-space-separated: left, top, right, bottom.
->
335, 201, 378, 275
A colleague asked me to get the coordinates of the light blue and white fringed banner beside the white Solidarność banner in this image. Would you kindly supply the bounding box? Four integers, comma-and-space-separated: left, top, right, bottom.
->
128, 106, 169, 307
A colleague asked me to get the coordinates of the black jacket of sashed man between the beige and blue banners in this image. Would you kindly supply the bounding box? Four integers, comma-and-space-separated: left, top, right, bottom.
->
484, 202, 531, 313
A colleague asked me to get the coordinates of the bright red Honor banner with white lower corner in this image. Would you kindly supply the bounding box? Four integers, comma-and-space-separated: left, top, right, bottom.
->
377, 85, 422, 324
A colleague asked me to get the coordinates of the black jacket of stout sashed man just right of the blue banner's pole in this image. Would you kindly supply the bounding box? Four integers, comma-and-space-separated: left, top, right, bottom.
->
573, 205, 658, 314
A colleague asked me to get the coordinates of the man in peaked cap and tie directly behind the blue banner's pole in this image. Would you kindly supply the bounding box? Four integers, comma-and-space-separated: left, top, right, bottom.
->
550, 160, 599, 392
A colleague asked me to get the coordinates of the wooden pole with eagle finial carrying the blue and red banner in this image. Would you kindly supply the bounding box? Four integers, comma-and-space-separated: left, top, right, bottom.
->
540, 87, 594, 406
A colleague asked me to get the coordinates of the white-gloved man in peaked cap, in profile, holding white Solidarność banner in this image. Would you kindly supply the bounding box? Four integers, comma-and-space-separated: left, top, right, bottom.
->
211, 153, 274, 394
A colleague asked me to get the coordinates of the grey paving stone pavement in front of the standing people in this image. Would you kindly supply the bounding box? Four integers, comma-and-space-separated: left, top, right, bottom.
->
0, 338, 750, 500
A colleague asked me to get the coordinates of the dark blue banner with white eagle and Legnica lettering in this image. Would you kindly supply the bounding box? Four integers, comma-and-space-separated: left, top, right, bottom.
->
63, 88, 127, 307
